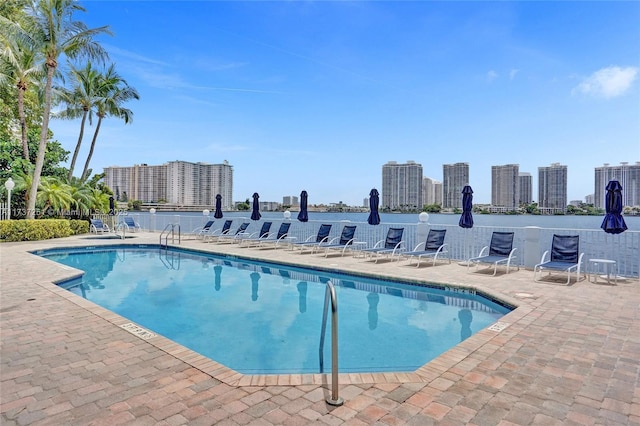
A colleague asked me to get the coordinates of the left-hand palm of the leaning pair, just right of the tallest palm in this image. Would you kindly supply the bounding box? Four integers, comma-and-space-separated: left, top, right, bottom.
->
58, 62, 101, 182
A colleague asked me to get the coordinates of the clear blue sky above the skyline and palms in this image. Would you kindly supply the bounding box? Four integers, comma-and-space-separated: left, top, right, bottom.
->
51, 1, 640, 205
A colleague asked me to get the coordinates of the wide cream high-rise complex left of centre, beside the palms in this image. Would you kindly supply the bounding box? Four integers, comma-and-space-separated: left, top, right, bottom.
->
104, 160, 233, 209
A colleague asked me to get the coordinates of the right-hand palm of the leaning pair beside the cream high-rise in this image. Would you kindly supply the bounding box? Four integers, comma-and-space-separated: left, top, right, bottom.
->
80, 64, 140, 181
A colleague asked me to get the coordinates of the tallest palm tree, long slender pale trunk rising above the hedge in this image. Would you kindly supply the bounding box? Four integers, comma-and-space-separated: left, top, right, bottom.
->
21, 0, 110, 219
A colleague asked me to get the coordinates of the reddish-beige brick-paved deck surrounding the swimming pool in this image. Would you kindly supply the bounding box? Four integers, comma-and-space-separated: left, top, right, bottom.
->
0, 232, 640, 425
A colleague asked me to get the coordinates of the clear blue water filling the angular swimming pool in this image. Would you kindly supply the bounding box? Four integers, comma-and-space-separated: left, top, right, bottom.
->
35, 246, 511, 374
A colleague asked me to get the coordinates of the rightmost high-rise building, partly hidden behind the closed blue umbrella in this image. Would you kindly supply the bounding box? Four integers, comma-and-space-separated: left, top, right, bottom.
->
593, 161, 640, 209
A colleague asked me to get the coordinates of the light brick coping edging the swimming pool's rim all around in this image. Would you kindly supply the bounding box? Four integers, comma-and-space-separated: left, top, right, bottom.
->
28, 240, 533, 387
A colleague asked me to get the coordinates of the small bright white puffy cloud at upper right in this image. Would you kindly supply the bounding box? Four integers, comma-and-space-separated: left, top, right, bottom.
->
573, 66, 638, 98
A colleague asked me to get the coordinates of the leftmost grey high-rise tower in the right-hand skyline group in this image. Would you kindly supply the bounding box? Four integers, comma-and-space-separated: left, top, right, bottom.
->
381, 161, 423, 210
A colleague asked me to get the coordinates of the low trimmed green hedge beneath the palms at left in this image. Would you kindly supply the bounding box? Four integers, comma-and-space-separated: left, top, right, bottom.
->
0, 219, 89, 242
